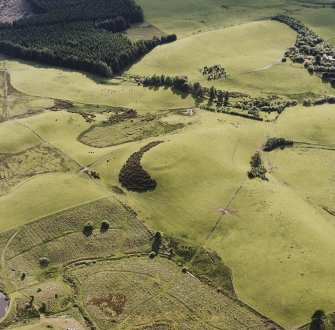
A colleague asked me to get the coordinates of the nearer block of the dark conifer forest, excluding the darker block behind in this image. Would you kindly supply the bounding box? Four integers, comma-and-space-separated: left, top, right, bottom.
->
0, 22, 173, 77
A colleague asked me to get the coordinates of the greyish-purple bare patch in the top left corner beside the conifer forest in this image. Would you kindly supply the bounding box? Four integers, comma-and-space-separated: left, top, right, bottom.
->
0, 0, 33, 23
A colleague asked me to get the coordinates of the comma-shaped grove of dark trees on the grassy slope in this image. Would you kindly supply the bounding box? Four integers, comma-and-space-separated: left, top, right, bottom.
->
119, 141, 162, 192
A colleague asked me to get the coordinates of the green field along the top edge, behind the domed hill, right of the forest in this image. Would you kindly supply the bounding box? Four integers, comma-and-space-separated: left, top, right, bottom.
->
137, 0, 291, 36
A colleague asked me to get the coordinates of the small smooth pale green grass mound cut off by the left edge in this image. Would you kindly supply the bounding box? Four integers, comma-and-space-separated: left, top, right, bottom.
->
0, 121, 41, 154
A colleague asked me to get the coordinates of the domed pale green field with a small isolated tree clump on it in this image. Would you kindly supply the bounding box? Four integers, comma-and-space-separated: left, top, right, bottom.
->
129, 21, 334, 96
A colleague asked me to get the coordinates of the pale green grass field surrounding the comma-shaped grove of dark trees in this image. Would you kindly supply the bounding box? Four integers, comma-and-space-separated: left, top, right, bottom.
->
94, 111, 265, 243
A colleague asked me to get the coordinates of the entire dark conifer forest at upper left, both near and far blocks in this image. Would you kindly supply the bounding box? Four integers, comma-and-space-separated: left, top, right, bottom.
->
0, 0, 175, 77
